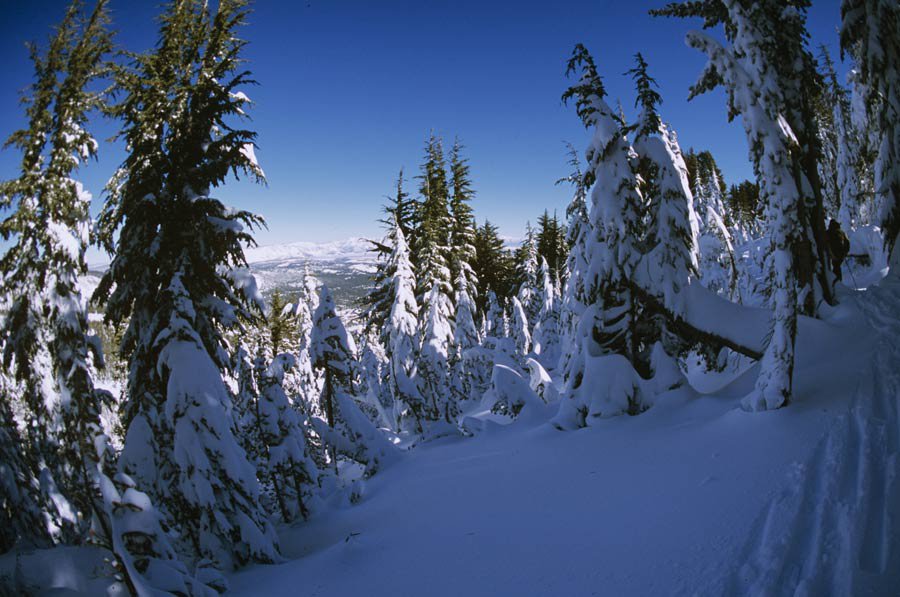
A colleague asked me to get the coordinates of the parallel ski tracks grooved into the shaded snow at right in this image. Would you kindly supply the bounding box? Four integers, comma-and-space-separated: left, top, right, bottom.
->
716, 279, 900, 597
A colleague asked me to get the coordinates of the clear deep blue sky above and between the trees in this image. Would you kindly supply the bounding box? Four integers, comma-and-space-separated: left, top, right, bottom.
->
0, 0, 839, 261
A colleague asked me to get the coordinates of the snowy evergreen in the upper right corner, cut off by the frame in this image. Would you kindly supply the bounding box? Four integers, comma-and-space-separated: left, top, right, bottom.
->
841, 0, 900, 272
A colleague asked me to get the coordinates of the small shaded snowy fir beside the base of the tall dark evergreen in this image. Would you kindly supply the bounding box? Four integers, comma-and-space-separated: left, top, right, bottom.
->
255, 353, 319, 522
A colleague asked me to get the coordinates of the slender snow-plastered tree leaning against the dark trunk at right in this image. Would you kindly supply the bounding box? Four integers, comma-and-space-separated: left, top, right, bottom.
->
688, 0, 810, 410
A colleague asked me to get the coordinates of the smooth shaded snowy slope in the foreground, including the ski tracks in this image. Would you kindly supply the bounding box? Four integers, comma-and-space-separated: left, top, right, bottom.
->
223, 282, 900, 596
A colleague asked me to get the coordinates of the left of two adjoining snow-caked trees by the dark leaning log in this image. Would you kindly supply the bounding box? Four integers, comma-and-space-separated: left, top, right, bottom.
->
556, 44, 645, 427
